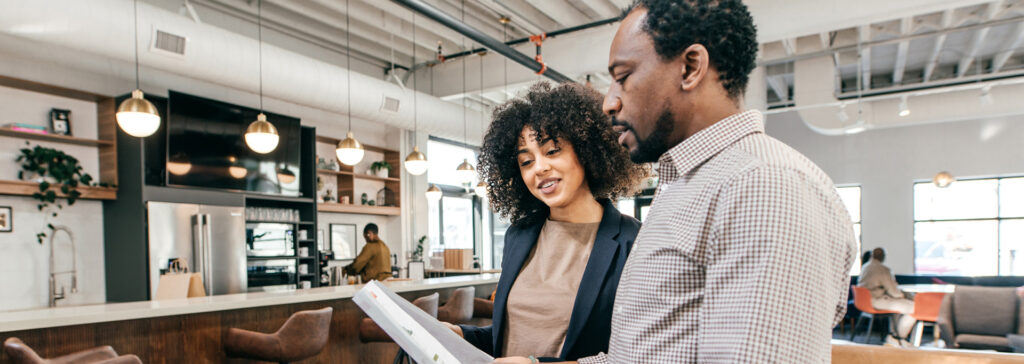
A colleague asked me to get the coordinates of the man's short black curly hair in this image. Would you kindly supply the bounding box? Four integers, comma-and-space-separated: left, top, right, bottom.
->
623, 0, 758, 99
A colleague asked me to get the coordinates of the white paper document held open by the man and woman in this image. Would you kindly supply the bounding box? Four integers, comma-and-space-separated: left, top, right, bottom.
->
352, 281, 495, 364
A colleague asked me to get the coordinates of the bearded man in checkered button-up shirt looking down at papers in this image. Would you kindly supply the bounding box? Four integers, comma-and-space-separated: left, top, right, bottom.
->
491, 0, 857, 363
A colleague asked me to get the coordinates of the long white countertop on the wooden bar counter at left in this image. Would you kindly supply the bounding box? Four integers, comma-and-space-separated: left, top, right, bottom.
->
0, 274, 499, 332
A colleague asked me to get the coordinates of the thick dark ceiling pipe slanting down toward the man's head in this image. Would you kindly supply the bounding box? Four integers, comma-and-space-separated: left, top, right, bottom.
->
391, 0, 573, 82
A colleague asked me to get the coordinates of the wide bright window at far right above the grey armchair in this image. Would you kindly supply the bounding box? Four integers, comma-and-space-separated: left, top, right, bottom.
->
913, 177, 1024, 276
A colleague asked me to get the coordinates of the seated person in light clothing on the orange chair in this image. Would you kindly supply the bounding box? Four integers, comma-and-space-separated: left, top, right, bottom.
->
857, 248, 915, 343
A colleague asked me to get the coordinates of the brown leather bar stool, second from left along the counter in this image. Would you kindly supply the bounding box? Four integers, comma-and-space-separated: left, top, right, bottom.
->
224, 308, 334, 363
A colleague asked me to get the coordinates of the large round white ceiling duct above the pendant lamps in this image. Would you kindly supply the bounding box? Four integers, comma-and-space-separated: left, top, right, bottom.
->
0, 0, 479, 143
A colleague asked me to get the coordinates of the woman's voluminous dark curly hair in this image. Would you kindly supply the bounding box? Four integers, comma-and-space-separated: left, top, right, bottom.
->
477, 81, 648, 226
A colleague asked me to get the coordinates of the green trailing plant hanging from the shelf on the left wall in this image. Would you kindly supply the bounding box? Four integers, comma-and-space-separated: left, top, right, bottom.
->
15, 141, 96, 244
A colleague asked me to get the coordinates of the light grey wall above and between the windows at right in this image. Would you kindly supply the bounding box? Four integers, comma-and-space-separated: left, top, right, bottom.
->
766, 112, 1024, 274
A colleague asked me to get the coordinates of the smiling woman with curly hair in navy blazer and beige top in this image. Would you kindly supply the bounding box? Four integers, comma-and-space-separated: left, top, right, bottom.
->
442, 82, 647, 360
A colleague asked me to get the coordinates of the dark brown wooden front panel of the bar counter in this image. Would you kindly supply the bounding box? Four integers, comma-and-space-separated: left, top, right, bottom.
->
0, 283, 497, 364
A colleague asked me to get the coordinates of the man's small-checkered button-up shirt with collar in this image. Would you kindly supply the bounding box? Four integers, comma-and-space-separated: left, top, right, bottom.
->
580, 111, 857, 363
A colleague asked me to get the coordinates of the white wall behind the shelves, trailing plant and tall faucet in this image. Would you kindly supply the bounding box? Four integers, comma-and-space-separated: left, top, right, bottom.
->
0, 86, 106, 311
